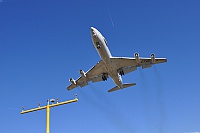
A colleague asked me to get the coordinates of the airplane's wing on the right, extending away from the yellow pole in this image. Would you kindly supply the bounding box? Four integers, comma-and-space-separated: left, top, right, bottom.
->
111, 57, 167, 75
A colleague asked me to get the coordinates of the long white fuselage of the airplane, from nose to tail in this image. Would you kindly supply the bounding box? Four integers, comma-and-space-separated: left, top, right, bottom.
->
91, 27, 123, 88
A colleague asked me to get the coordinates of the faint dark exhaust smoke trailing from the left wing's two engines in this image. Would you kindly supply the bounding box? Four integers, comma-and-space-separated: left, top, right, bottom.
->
80, 84, 135, 133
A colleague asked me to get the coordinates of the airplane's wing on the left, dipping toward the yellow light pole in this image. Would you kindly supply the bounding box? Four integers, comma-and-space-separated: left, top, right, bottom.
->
67, 61, 108, 90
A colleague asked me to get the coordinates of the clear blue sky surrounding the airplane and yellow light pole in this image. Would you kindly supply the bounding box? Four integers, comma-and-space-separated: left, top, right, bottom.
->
0, 0, 200, 133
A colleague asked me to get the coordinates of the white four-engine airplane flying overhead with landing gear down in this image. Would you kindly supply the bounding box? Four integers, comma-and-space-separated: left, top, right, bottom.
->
67, 27, 167, 92
